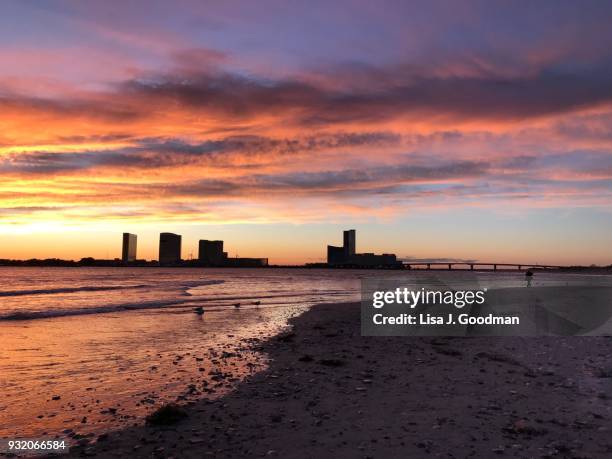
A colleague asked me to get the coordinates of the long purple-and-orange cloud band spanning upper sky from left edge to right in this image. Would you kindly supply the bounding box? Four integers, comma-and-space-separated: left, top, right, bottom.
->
0, 60, 612, 127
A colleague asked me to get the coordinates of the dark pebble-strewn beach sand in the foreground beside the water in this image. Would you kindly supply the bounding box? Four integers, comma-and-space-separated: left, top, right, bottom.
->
71, 304, 612, 458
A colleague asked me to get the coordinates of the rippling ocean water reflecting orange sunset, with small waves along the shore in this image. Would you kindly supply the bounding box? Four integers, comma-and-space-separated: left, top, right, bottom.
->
0, 267, 609, 438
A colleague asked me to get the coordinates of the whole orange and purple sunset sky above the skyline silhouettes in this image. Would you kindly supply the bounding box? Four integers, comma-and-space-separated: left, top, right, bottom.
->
0, 0, 612, 264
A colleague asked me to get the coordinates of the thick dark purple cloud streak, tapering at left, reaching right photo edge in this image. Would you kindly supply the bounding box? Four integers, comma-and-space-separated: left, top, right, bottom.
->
119, 68, 612, 126
